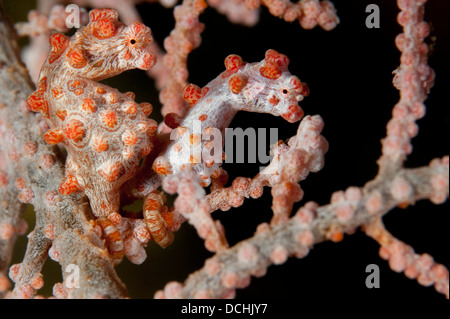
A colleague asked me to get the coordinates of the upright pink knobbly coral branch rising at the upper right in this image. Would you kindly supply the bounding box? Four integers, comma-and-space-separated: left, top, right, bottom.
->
378, 0, 434, 170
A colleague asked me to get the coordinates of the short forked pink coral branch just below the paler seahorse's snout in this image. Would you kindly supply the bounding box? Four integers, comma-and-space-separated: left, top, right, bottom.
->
207, 115, 328, 224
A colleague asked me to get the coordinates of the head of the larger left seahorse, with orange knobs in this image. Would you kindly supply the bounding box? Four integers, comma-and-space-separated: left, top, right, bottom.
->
48, 9, 156, 81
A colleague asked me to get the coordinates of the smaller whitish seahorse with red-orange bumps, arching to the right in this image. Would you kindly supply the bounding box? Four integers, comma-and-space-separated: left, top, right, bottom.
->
153, 50, 309, 187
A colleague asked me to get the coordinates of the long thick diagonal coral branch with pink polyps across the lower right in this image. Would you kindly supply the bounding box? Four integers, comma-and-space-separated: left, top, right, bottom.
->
155, 157, 449, 298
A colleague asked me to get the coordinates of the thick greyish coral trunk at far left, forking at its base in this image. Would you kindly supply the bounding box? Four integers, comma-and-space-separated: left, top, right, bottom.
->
0, 4, 126, 298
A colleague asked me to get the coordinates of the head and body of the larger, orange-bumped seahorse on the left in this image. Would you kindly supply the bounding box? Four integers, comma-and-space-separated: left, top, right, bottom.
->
28, 9, 157, 217
